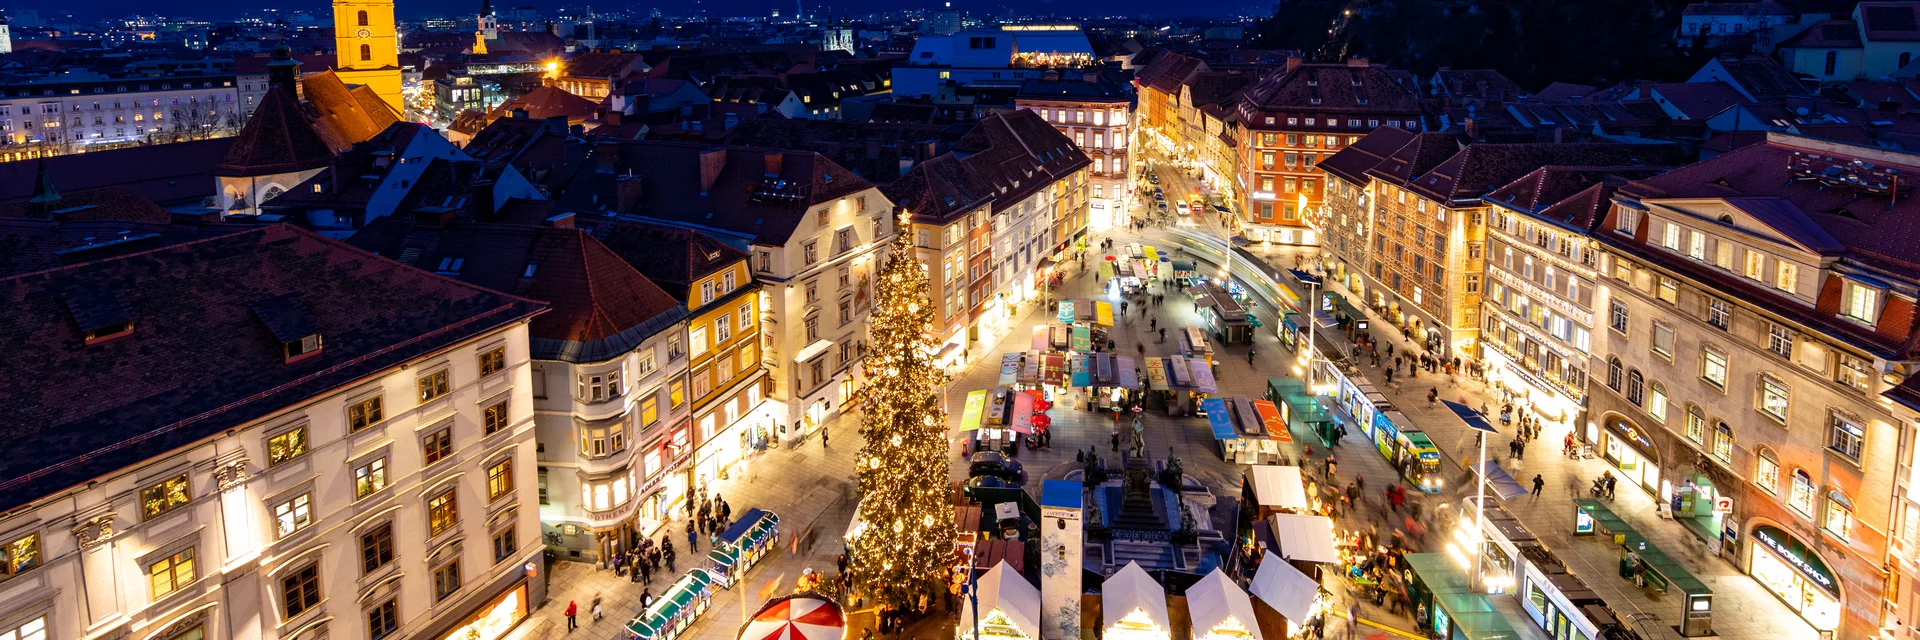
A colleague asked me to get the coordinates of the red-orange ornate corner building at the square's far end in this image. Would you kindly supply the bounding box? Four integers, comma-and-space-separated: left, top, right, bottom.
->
1235, 58, 1421, 246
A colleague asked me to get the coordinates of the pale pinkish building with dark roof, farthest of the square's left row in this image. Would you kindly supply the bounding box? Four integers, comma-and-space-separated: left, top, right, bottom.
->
1014, 71, 1133, 231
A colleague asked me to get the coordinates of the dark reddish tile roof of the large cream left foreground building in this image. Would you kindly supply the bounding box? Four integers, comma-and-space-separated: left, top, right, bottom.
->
0, 225, 541, 511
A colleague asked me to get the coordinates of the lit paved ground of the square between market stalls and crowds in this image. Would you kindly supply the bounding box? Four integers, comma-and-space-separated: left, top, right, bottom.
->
533, 221, 1816, 640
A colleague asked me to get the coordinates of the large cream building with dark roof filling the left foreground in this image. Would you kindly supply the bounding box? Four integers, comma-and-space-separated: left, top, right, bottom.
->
0, 225, 545, 640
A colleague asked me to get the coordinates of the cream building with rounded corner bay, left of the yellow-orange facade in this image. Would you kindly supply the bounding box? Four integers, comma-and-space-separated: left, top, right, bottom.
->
348, 215, 693, 561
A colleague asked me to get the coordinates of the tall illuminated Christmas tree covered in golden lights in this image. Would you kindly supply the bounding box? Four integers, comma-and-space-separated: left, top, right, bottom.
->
849, 213, 954, 607
